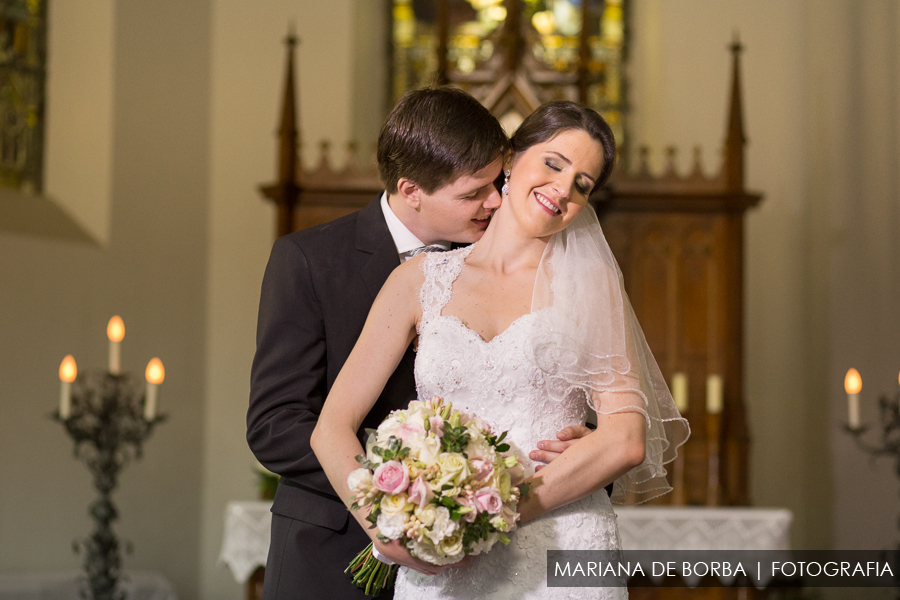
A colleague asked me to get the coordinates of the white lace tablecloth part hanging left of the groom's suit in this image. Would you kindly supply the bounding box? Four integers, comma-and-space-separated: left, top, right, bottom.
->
219, 502, 272, 583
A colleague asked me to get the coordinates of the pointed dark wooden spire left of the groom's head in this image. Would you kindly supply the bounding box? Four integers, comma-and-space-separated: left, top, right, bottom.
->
259, 27, 300, 237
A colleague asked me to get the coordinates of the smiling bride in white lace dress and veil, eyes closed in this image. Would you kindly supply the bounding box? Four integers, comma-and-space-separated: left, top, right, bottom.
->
312, 102, 689, 599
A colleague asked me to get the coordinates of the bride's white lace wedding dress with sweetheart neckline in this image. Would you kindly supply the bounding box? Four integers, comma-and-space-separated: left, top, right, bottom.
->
394, 246, 628, 600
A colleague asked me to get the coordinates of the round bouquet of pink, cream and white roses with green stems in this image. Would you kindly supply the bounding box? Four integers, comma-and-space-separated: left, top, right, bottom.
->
347, 396, 528, 595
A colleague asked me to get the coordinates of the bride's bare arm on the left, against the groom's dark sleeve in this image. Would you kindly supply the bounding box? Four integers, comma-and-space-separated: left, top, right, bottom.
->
311, 259, 443, 574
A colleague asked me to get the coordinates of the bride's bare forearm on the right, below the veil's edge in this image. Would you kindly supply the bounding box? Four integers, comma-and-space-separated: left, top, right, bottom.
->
518, 392, 647, 522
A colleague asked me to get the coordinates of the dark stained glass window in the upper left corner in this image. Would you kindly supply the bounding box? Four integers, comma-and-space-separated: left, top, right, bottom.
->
0, 0, 47, 193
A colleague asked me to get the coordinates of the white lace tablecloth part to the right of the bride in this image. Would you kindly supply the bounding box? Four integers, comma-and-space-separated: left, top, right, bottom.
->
616, 506, 794, 550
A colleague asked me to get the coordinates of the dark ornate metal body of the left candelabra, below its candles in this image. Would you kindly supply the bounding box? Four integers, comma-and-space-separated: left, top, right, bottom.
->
53, 371, 165, 600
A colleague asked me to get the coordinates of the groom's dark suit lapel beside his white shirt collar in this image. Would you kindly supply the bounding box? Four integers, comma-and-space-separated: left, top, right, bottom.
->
356, 195, 400, 300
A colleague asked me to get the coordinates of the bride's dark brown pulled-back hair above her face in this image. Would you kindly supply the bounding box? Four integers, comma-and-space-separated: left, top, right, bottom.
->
510, 100, 616, 187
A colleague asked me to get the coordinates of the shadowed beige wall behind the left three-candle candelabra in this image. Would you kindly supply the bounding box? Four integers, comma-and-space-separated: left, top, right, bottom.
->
0, 0, 210, 598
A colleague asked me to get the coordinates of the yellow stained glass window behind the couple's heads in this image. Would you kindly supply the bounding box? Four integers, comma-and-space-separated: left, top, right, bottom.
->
392, 0, 626, 143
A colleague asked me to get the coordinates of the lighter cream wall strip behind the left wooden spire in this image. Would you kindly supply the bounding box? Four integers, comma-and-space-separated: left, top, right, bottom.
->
201, 0, 354, 599
